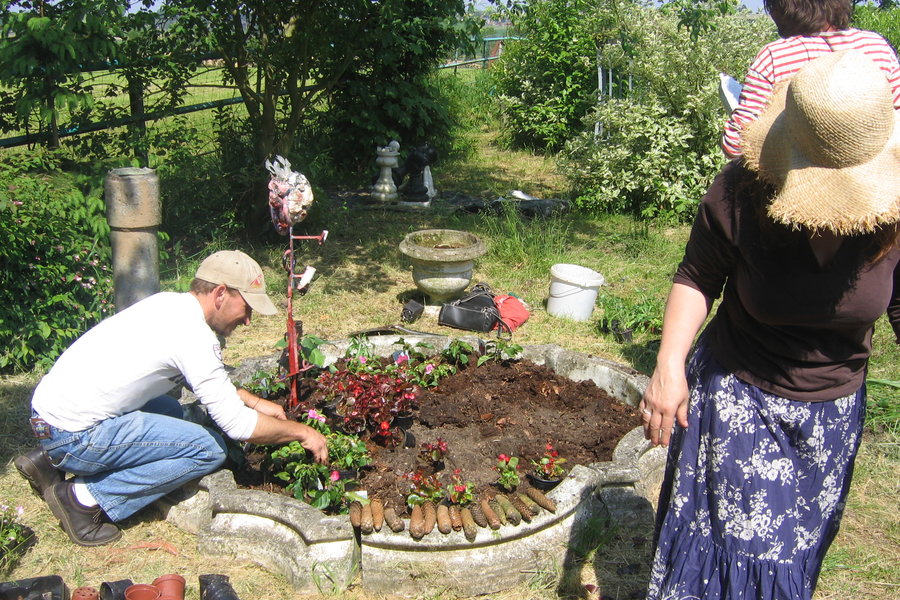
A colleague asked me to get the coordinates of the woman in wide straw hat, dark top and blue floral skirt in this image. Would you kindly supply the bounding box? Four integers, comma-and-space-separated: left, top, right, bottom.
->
640, 51, 900, 600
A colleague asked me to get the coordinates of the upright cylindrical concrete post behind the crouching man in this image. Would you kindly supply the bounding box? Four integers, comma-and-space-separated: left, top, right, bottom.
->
105, 167, 162, 311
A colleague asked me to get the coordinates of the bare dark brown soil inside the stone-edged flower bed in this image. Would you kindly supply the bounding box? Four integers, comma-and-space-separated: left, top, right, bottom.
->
236, 361, 639, 514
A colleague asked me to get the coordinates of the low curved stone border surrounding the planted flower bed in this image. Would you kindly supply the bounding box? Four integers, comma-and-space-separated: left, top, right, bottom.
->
159, 335, 665, 596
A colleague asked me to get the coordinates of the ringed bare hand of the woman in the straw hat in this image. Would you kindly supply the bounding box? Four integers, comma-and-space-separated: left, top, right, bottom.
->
638, 364, 688, 446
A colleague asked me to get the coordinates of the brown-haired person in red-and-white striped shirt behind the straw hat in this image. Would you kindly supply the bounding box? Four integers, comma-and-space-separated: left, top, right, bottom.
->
722, 0, 900, 158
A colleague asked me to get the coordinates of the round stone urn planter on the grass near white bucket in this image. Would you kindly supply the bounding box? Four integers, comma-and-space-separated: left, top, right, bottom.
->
400, 229, 486, 304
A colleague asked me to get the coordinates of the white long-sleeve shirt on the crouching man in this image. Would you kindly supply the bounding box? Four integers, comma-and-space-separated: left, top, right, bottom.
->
32, 292, 258, 440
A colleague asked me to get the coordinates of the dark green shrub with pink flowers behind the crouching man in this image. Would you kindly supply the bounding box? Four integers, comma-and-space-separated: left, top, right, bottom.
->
0, 156, 113, 372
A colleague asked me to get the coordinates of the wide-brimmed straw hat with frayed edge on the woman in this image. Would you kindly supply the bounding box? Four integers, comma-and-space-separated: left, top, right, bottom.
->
742, 50, 900, 235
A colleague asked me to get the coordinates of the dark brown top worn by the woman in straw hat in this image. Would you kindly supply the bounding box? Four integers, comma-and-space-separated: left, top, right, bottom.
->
674, 159, 900, 402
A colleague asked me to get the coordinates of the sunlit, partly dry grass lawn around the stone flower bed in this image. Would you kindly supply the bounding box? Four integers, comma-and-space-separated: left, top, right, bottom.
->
0, 125, 900, 600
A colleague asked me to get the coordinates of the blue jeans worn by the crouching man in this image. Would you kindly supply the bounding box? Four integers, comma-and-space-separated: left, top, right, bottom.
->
41, 396, 226, 521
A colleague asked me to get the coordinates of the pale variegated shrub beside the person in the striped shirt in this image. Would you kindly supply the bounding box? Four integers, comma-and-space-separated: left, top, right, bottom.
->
559, 9, 773, 221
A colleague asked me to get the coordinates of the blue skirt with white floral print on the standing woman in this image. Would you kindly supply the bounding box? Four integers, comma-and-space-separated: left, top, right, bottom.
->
647, 340, 865, 600
